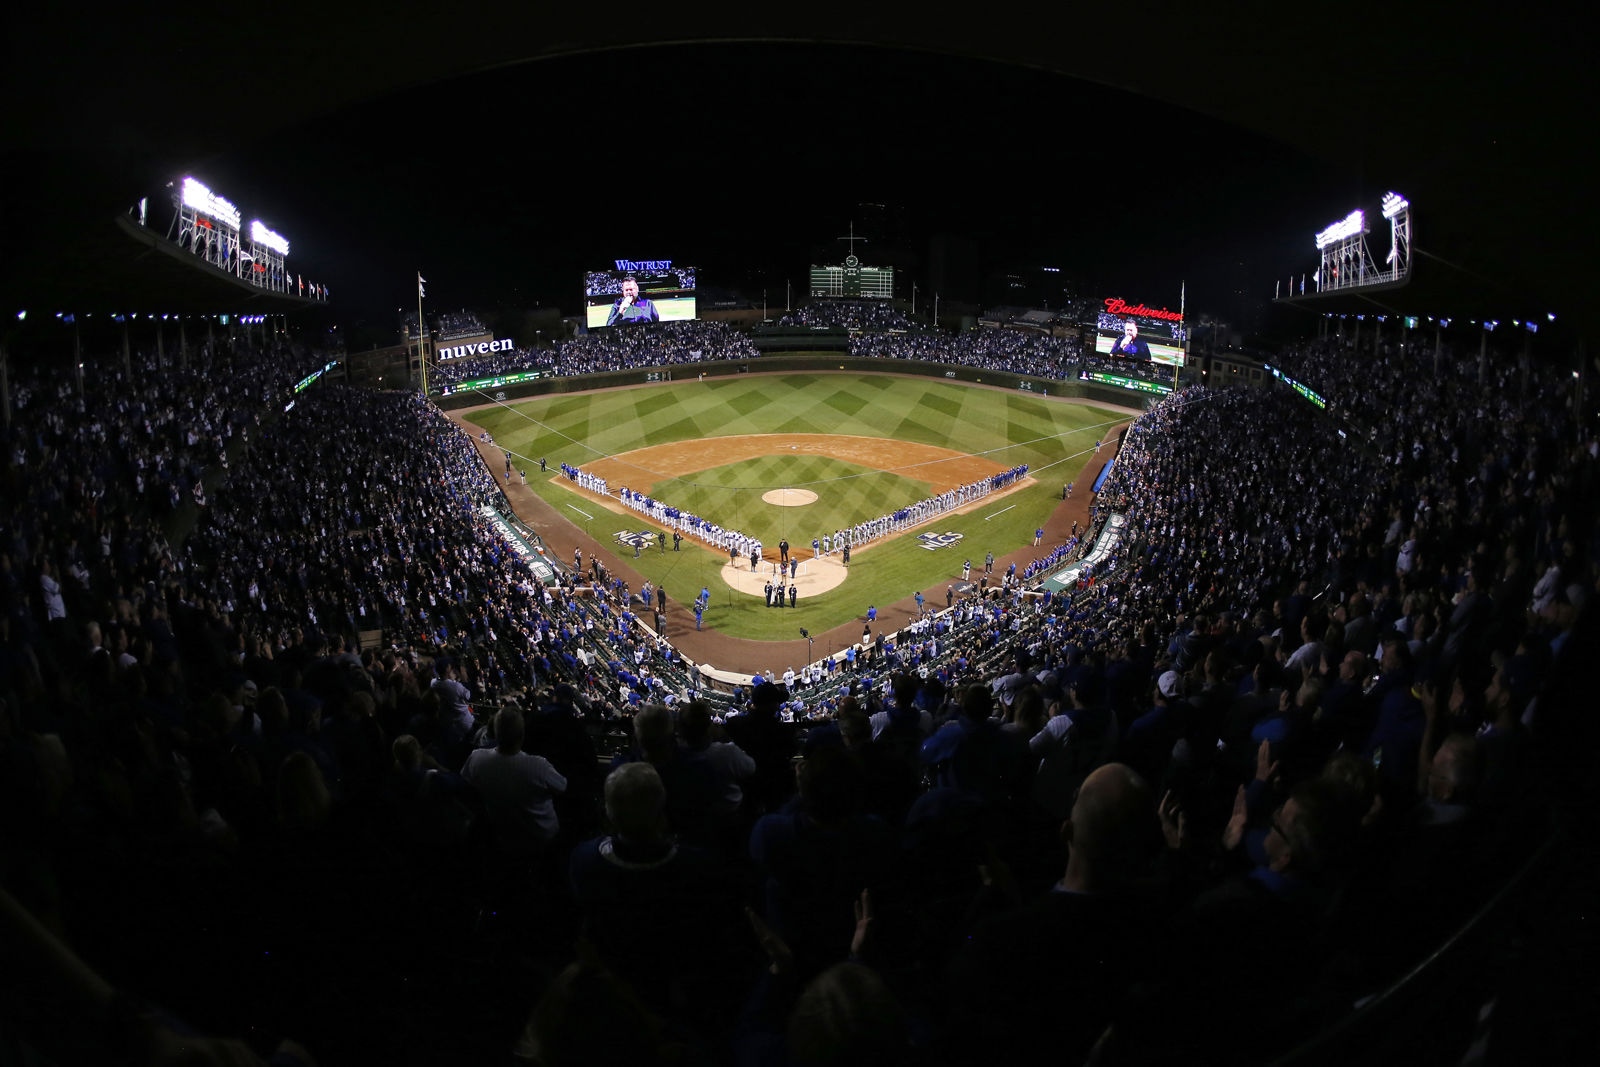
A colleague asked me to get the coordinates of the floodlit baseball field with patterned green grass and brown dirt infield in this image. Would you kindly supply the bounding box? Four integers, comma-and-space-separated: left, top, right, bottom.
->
459, 373, 1128, 653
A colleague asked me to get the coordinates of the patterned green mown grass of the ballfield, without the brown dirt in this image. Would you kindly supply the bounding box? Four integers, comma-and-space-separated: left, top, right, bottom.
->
467, 374, 1126, 643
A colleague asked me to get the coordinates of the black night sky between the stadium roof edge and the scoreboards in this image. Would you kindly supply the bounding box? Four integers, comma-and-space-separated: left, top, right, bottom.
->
190, 45, 1363, 328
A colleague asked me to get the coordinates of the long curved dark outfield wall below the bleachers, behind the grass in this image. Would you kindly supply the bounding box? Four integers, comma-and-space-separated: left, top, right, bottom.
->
434, 352, 1154, 411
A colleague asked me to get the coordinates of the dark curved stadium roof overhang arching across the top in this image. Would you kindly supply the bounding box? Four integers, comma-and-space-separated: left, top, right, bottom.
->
5, 3, 1597, 329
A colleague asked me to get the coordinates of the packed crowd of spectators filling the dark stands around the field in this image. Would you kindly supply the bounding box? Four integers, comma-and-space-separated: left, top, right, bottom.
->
0, 307, 1600, 1064
